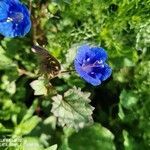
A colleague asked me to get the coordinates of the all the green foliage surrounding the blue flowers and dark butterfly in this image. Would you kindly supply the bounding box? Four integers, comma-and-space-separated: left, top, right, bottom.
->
0, 0, 150, 150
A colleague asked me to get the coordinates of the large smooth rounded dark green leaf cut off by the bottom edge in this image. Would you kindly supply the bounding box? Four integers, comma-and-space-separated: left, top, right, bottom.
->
68, 124, 115, 150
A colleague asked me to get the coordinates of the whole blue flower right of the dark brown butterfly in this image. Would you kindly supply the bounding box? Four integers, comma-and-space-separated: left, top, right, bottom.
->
74, 45, 112, 86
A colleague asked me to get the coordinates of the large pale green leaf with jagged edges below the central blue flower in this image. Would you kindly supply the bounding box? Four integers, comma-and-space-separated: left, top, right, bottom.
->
51, 87, 94, 129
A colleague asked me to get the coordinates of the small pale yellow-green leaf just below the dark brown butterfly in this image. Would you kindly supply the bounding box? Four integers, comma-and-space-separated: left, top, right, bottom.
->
30, 79, 47, 95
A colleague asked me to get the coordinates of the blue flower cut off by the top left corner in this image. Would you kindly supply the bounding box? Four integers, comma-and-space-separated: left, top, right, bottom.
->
0, 0, 31, 37
